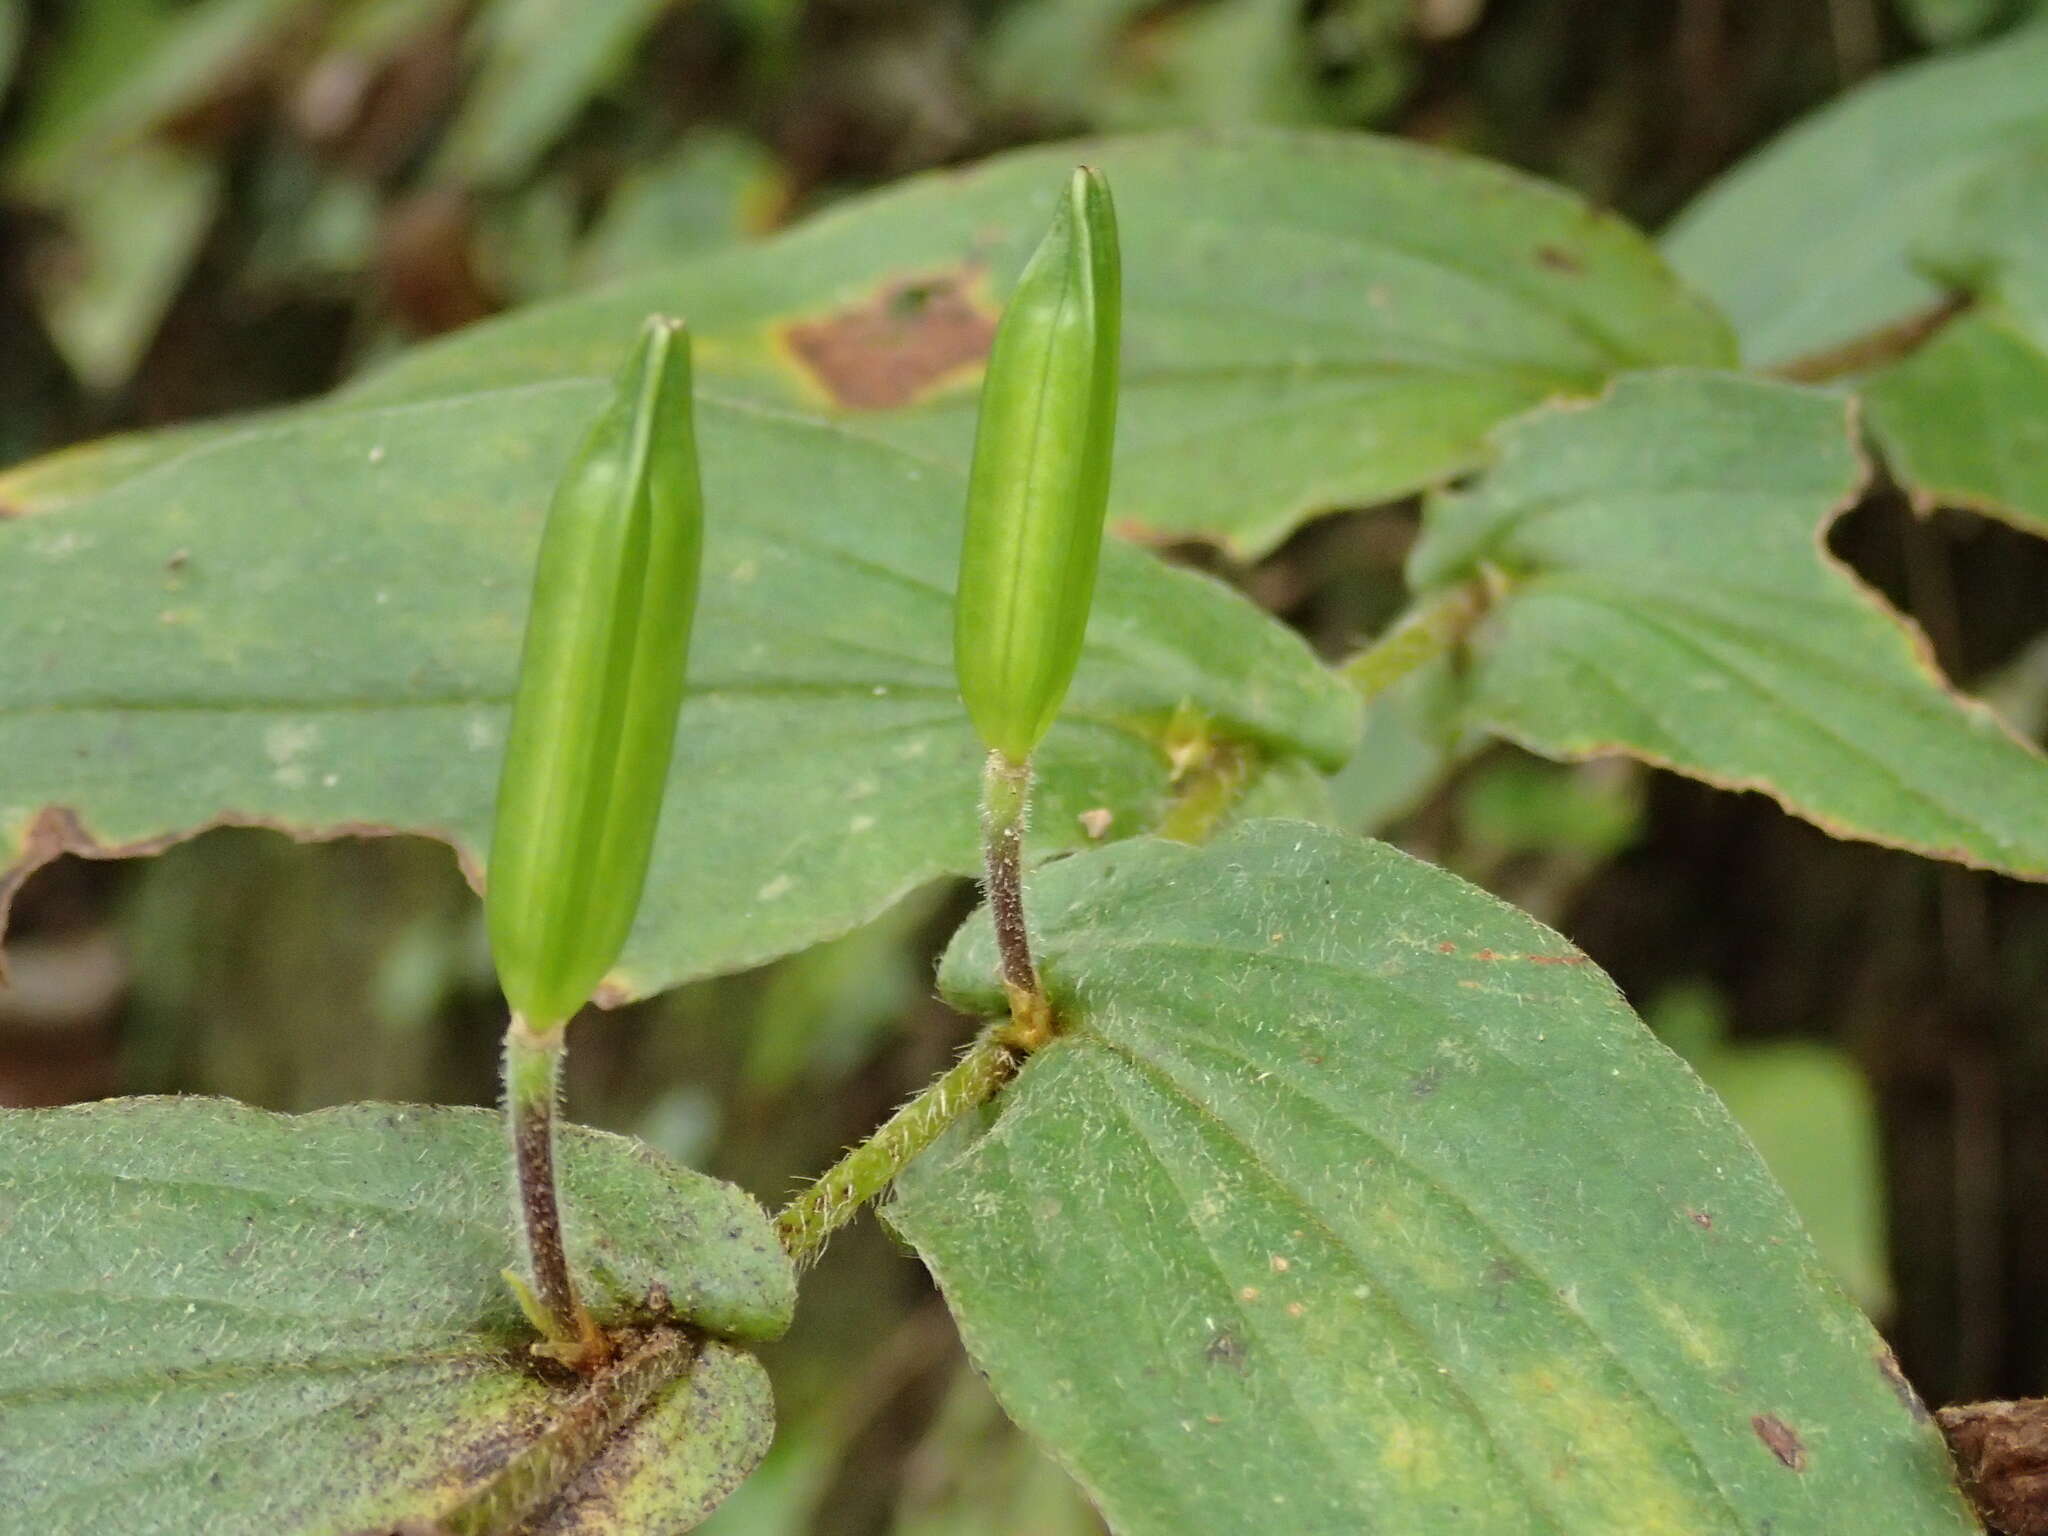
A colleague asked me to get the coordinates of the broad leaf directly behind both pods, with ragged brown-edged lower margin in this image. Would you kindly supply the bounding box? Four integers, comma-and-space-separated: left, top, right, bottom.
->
0, 374, 1356, 995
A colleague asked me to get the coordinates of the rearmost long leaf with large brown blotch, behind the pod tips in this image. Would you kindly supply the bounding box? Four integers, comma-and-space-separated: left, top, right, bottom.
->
4, 131, 1733, 555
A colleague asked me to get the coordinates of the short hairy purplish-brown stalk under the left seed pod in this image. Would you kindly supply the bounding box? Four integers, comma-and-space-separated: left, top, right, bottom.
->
506, 1014, 610, 1374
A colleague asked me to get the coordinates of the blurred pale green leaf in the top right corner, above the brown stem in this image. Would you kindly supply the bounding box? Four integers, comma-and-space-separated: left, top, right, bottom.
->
1665, 25, 2048, 365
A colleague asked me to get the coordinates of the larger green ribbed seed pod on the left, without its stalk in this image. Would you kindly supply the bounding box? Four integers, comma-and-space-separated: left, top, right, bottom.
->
485, 317, 705, 1032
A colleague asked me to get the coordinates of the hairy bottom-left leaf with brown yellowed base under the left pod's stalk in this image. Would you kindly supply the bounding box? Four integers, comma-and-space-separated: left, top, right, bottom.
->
0, 1100, 795, 1536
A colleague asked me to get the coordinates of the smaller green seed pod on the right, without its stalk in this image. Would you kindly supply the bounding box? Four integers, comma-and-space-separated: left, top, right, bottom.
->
952, 166, 1122, 762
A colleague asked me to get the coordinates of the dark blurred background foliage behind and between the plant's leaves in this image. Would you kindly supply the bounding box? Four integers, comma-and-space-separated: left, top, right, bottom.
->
0, 0, 2048, 1536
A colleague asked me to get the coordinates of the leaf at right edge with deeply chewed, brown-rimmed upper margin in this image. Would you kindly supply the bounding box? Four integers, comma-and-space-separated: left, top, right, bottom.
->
1409, 371, 2048, 879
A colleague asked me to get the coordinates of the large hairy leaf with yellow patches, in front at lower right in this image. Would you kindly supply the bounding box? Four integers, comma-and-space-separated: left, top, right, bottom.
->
889, 821, 1976, 1536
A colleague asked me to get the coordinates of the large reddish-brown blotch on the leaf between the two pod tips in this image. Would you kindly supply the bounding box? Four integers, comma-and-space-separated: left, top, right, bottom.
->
782, 268, 995, 412
